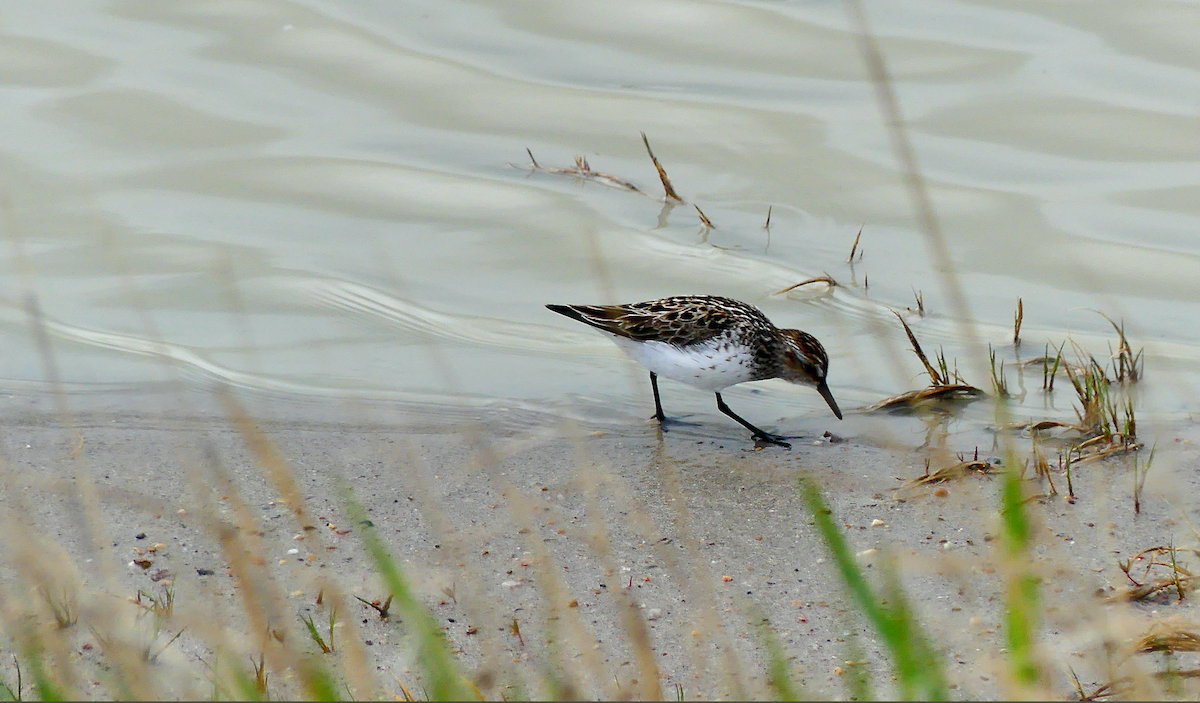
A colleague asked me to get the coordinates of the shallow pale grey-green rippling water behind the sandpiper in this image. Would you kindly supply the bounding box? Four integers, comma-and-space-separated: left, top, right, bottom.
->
0, 0, 1200, 437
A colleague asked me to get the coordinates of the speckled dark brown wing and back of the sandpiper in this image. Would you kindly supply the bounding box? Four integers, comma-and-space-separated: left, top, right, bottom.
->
546, 295, 774, 347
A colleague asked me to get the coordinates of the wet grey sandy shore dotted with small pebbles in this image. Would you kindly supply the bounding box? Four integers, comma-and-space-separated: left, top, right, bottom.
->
5, 388, 1200, 698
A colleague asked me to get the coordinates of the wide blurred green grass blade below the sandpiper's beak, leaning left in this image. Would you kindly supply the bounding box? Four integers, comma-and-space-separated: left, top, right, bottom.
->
800, 472, 947, 701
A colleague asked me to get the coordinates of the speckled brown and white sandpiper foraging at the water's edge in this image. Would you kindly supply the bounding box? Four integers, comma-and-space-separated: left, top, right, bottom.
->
546, 295, 841, 447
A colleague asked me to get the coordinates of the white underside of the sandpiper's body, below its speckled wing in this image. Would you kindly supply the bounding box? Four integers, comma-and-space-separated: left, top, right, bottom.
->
613, 336, 754, 392
